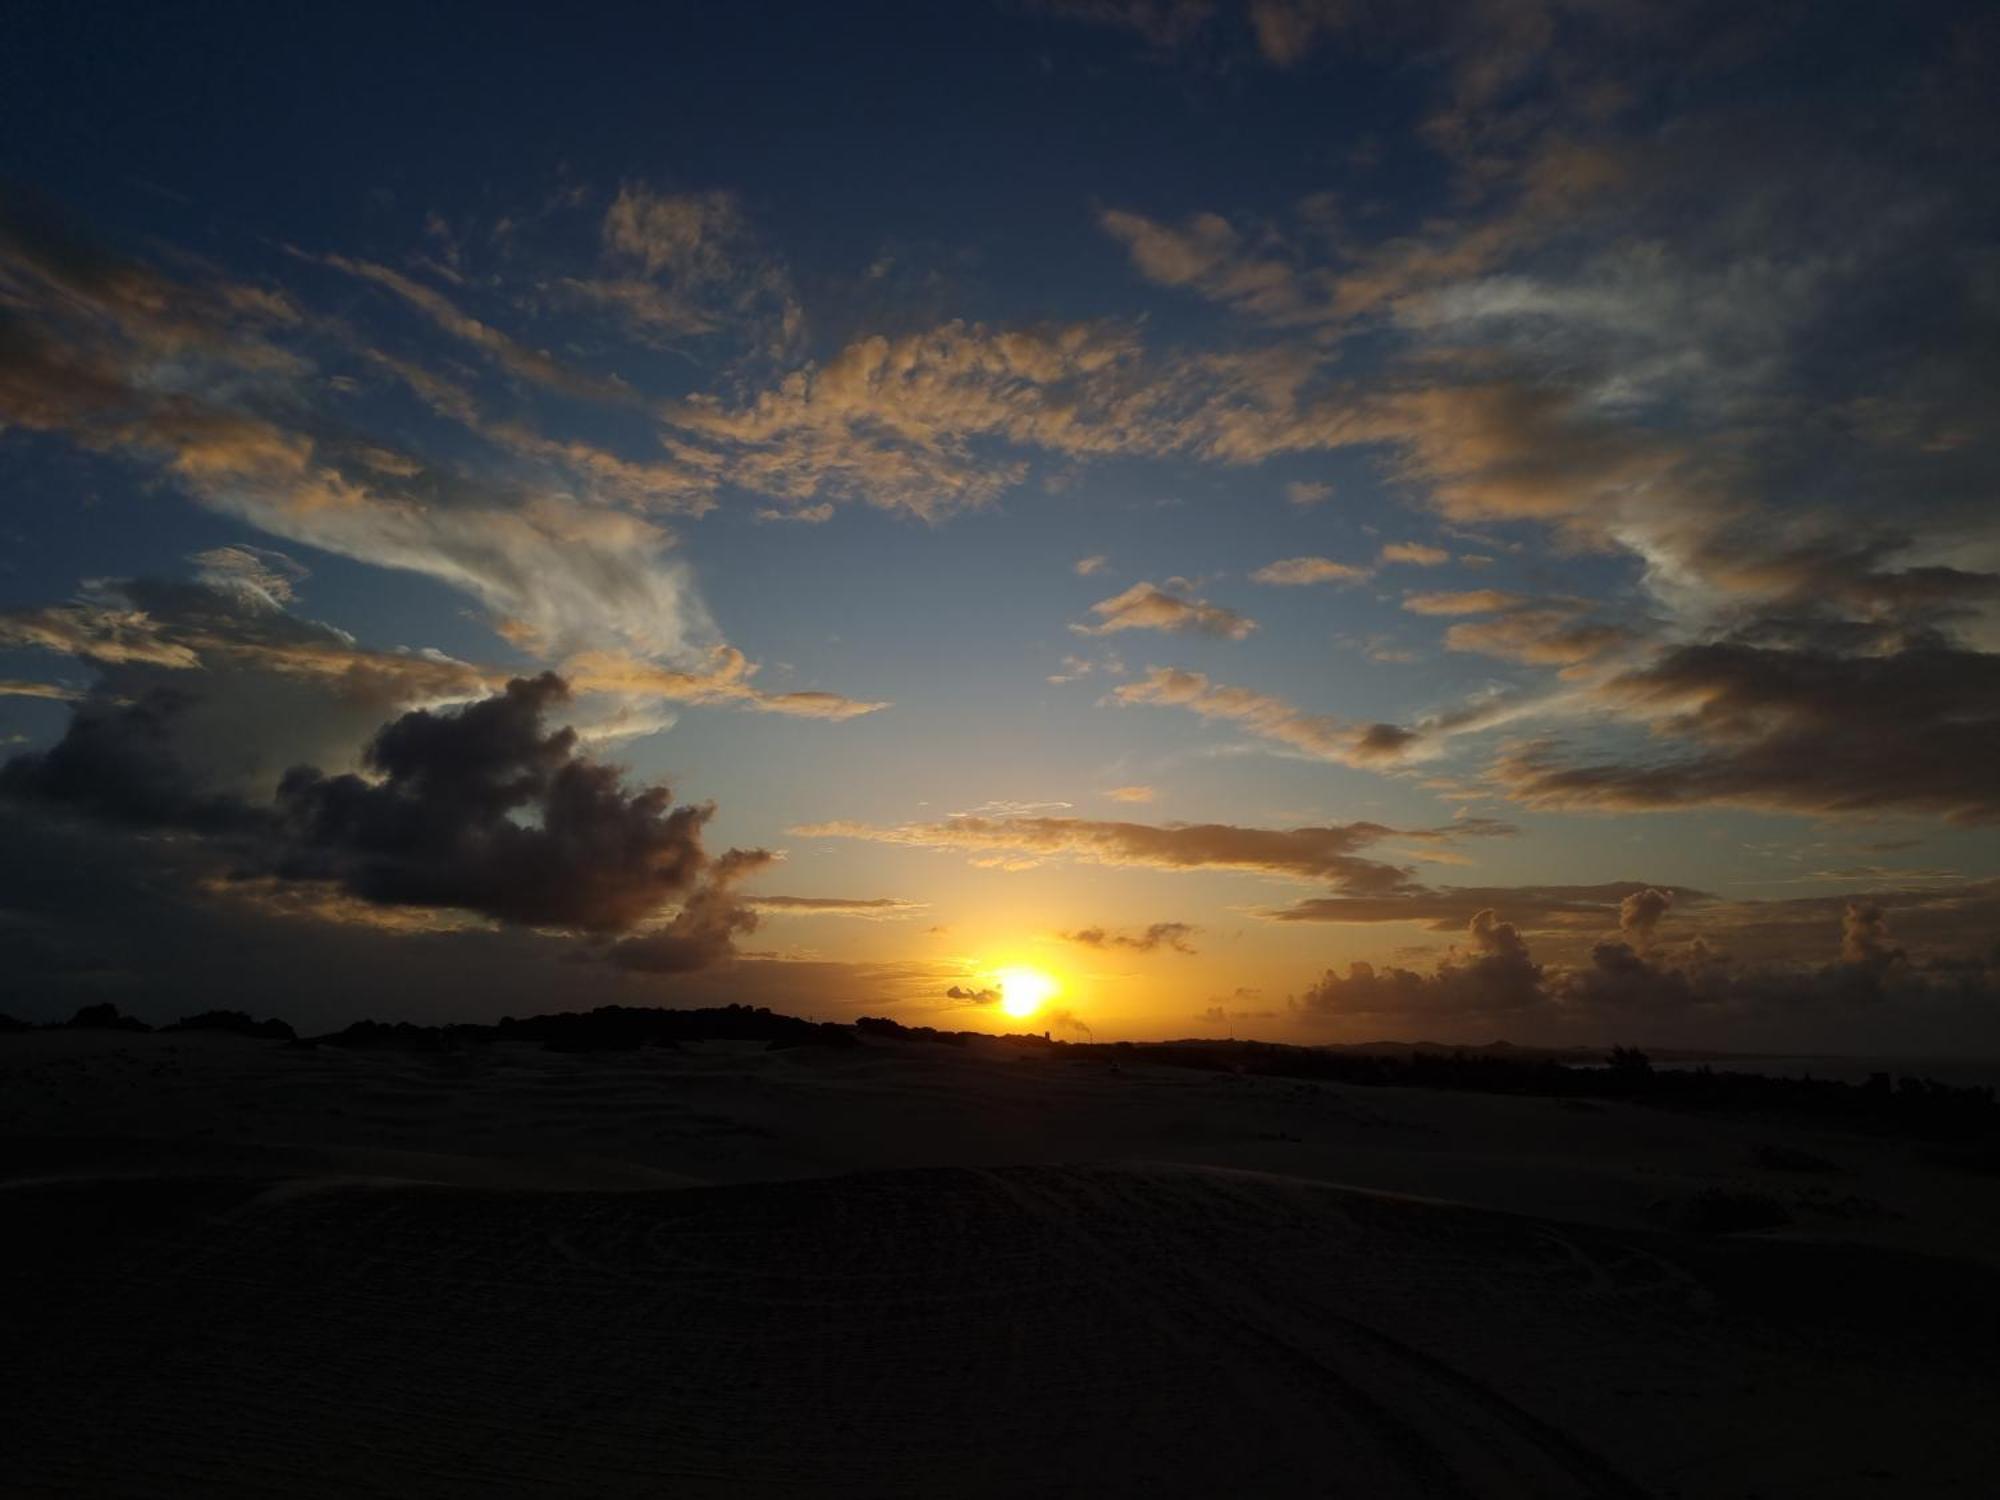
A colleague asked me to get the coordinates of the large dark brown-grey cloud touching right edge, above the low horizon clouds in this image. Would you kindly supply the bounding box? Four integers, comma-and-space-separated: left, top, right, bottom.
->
1490, 640, 2000, 824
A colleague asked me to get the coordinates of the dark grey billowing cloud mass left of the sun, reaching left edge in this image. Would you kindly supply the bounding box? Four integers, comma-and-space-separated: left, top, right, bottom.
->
0, 674, 772, 956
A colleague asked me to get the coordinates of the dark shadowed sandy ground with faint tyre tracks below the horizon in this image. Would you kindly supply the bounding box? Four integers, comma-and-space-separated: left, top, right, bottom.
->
0, 1032, 2000, 1498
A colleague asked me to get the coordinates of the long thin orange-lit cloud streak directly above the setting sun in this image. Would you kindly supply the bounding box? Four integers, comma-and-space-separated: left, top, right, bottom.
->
792, 814, 1504, 896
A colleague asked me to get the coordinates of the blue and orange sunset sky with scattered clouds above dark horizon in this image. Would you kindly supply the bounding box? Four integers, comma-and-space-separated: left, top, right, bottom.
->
0, 0, 2000, 1056
